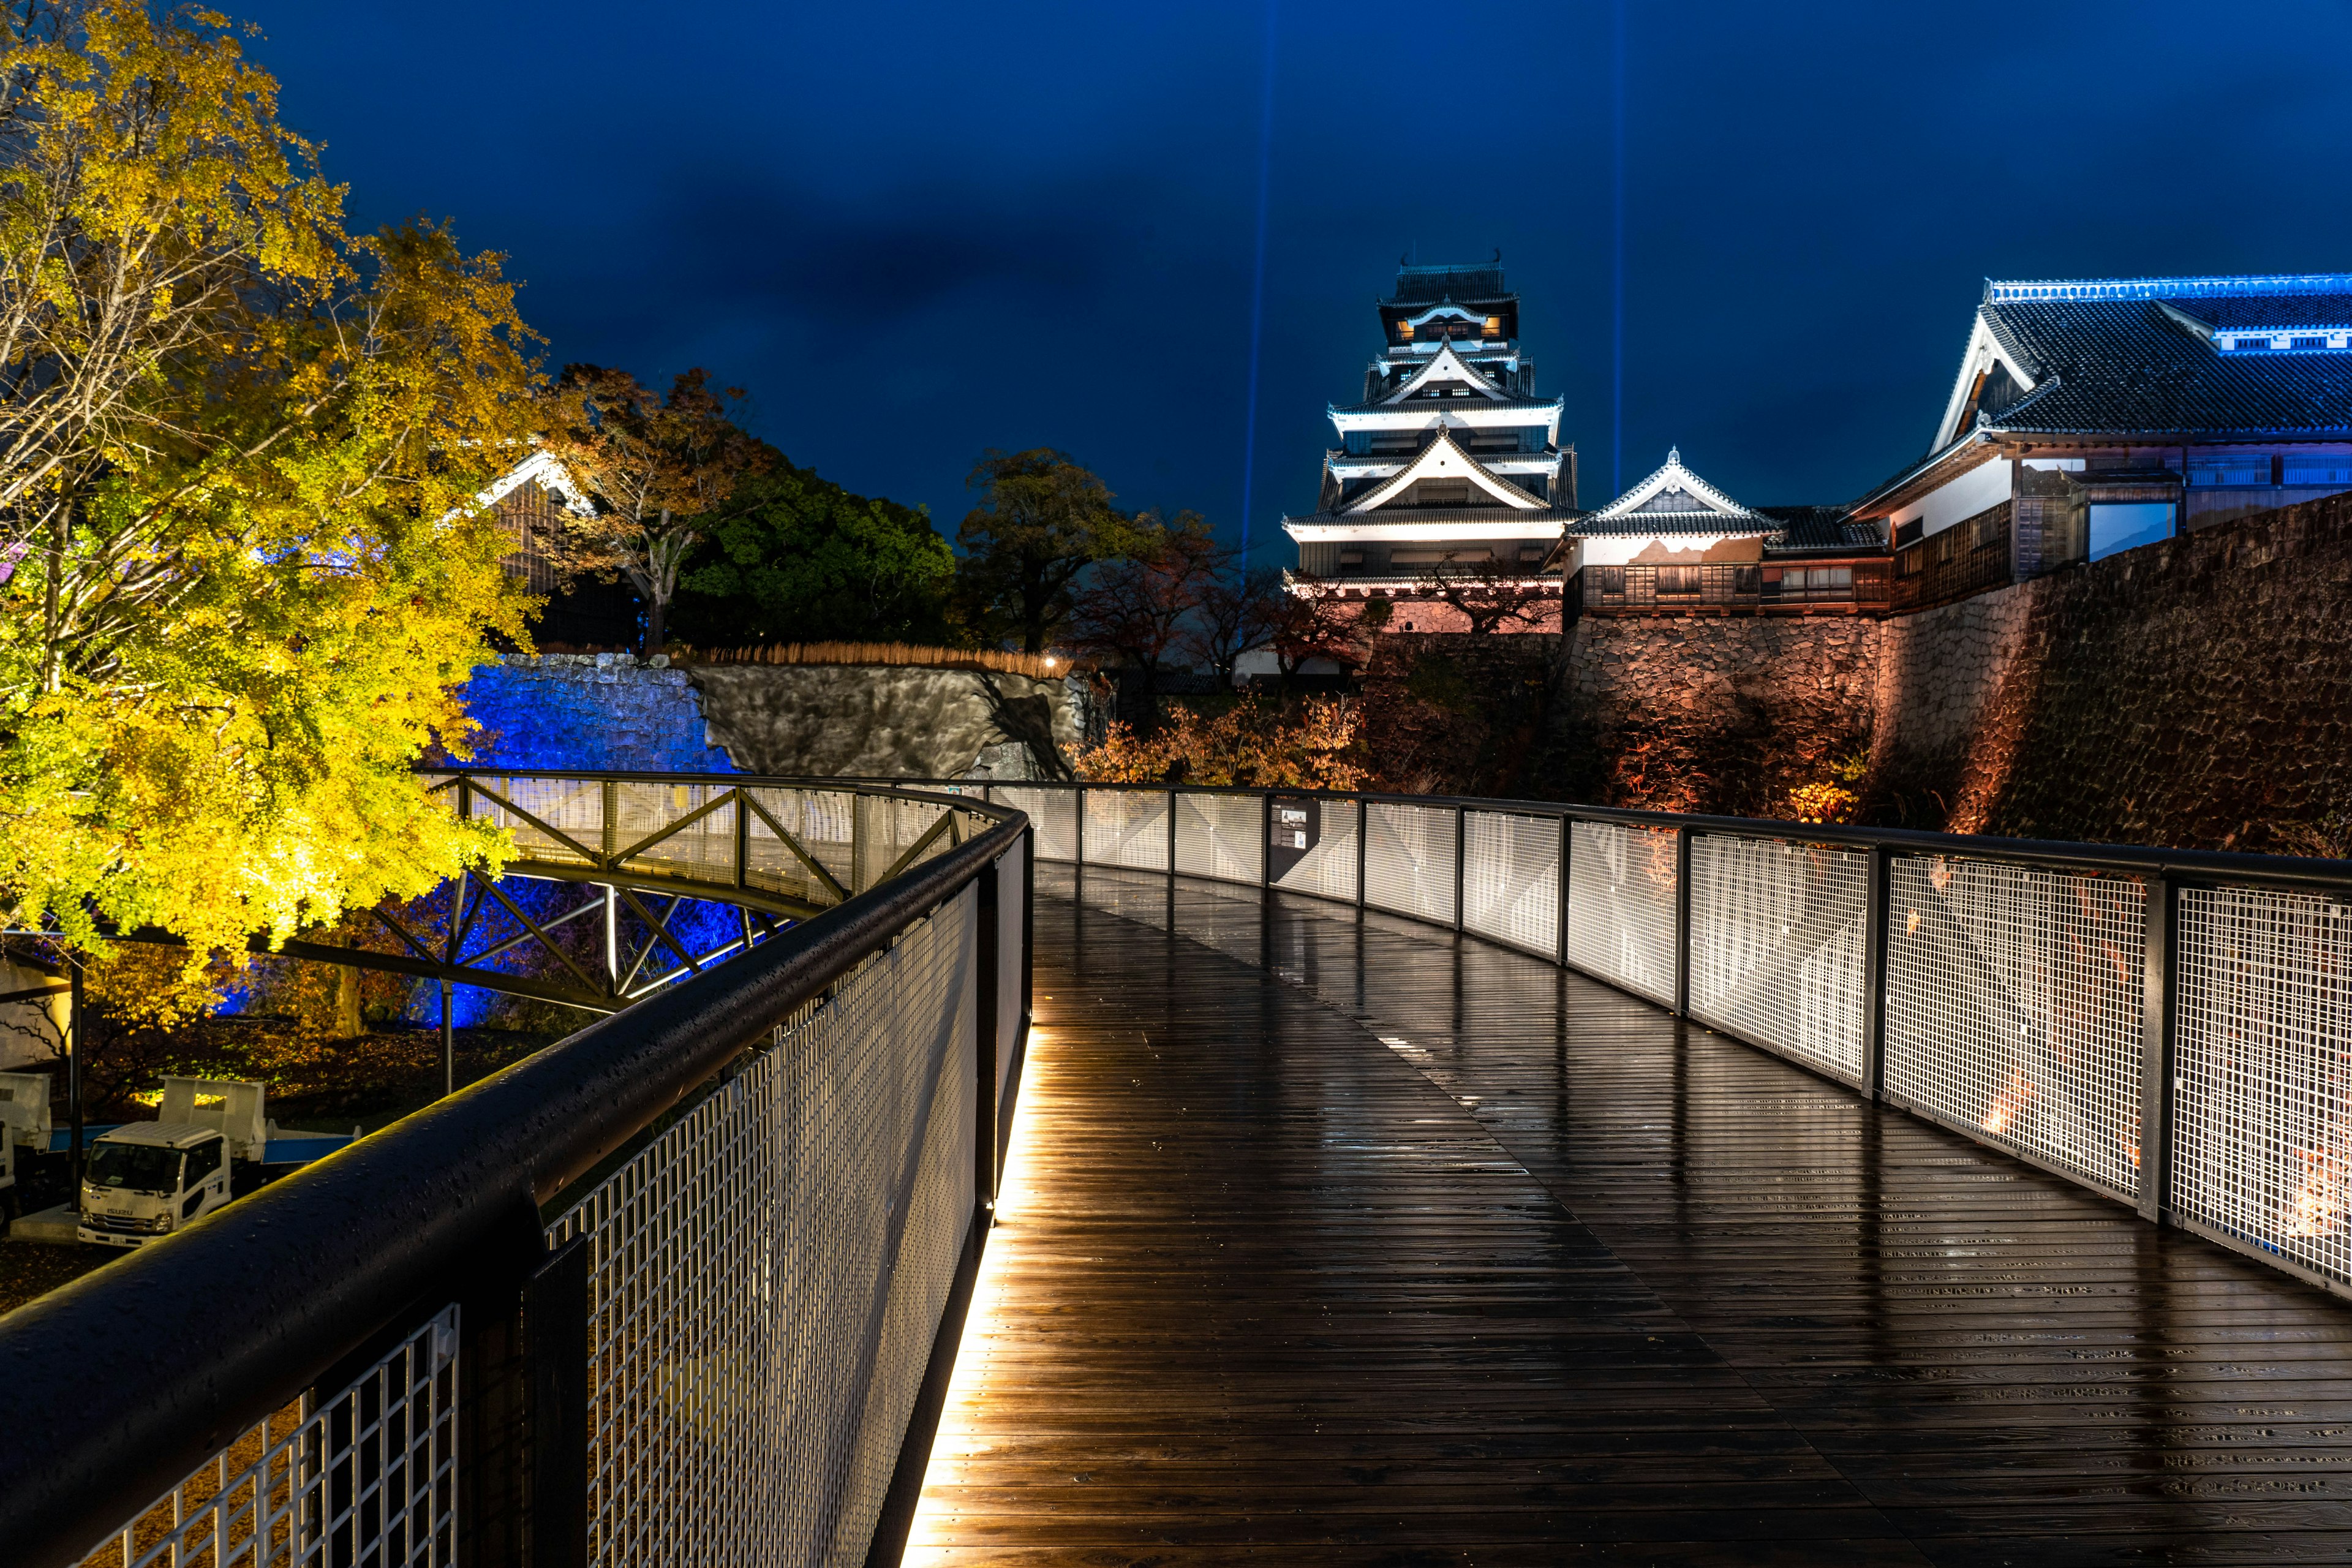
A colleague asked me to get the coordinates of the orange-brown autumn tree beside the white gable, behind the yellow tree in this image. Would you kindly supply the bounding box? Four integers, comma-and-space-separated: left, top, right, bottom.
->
546, 364, 774, 654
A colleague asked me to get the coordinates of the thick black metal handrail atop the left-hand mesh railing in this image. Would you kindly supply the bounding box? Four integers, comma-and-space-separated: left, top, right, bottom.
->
0, 799, 1025, 1568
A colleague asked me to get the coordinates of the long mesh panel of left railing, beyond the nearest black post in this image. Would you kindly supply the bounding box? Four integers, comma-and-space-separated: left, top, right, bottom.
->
548, 886, 978, 1568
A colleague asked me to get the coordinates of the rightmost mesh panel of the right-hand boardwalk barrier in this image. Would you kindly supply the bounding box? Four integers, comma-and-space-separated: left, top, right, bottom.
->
2171, 889, 2352, 1281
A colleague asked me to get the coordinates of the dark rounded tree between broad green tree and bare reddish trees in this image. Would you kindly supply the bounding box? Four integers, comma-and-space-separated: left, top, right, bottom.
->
955, 447, 1136, 654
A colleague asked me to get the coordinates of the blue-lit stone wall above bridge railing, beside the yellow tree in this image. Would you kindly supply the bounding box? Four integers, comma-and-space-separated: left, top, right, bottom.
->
447, 654, 736, 774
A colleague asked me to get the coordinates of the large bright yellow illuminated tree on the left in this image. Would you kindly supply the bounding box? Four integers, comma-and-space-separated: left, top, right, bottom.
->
0, 0, 538, 1011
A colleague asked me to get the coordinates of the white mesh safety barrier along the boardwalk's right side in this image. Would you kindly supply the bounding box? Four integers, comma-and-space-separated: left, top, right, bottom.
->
983, 783, 2352, 1293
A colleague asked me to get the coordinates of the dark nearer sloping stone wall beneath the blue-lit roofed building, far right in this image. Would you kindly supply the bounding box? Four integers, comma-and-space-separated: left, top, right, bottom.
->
1870, 496, 2352, 853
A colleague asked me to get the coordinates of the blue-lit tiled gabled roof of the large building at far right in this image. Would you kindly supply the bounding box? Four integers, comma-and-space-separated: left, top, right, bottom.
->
1931, 273, 2352, 451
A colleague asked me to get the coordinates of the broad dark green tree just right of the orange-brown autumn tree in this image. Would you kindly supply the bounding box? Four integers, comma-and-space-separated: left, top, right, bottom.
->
677, 454, 955, 646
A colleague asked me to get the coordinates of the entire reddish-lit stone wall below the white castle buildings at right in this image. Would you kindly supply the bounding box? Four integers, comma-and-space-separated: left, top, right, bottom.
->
1531, 496, 2352, 853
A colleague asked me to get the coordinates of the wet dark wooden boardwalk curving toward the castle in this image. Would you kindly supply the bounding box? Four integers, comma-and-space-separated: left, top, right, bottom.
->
908, 867, 2352, 1568
